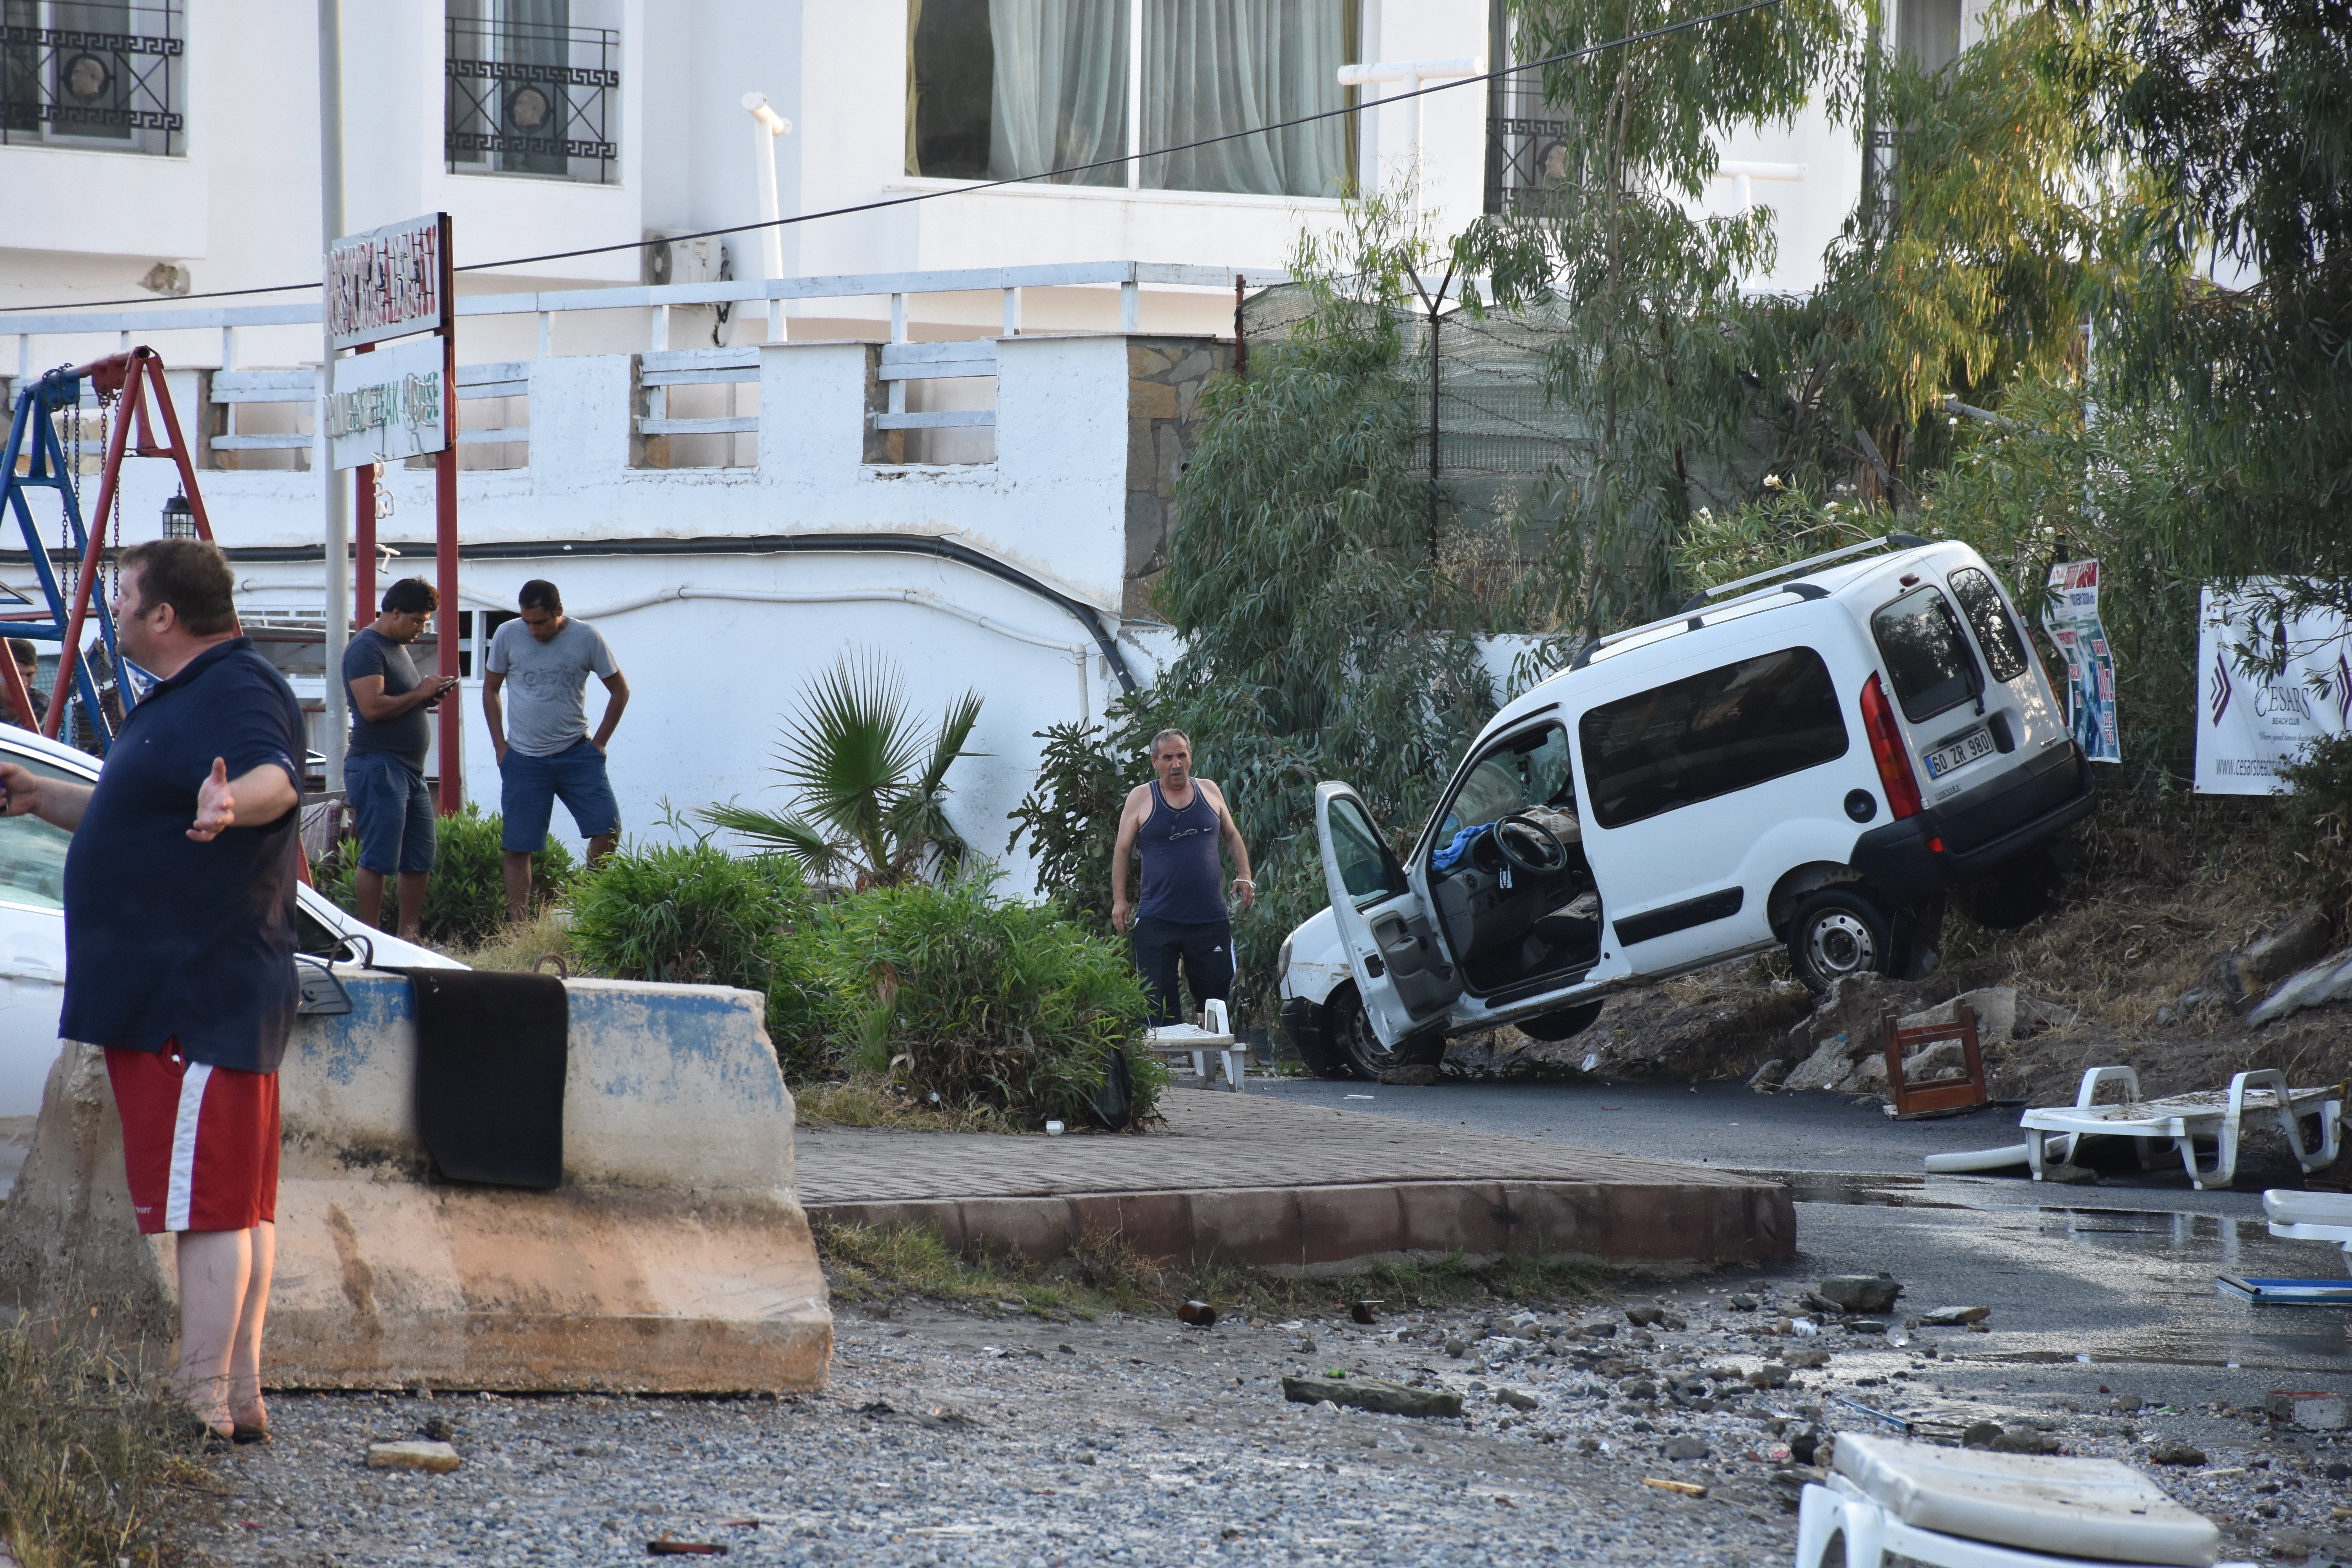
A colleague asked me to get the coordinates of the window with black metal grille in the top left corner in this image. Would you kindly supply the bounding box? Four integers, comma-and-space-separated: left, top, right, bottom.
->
0, 0, 188, 158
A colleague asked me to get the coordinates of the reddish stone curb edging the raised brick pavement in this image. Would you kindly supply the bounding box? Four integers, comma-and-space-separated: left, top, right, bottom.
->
809, 1180, 1797, 1276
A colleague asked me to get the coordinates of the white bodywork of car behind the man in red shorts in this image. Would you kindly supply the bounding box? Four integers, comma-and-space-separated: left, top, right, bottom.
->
0, 729, 459, 1123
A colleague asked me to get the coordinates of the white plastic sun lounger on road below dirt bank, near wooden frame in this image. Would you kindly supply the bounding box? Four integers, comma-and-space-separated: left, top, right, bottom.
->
2018, 1067, 2343, 1192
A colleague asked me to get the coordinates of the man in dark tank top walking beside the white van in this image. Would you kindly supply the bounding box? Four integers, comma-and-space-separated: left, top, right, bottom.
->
1110, 729, 1258, 1025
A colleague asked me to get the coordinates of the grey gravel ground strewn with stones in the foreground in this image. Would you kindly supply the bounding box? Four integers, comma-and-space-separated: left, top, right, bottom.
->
186, 1279, 2352, 1568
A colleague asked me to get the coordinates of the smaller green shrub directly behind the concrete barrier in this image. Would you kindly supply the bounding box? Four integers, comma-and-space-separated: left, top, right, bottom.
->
572, 844, 809, 992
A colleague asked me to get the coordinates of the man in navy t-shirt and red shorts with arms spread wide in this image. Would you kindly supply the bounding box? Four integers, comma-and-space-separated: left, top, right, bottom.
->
0, 538, 303, 1441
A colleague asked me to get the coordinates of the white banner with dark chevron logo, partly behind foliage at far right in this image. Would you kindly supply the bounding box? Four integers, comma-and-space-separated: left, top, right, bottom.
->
2197, 578, 2352, 795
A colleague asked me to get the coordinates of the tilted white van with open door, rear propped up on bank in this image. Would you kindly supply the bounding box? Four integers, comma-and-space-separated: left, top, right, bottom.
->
1279, 534, 2091, 1077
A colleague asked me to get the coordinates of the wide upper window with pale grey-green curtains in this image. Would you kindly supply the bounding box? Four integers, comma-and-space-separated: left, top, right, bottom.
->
906, 0, 1359, 195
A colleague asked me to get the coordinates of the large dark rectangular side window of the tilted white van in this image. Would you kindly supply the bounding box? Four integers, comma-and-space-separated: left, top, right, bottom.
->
1576, 649, 1846, 828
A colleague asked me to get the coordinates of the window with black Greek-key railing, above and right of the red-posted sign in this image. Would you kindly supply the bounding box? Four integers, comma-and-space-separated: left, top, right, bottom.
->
442, 16, 621, 186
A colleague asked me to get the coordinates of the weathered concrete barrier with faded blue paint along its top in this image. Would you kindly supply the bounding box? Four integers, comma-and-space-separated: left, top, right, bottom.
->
0, 969, 833, 1394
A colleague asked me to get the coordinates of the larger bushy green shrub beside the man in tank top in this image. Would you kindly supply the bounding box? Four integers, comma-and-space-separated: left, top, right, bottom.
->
769, 879, 1167, 1126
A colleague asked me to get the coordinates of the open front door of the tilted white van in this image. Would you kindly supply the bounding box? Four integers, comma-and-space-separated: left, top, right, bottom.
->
1315, 783, 1463, 1046
